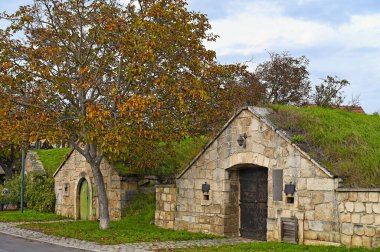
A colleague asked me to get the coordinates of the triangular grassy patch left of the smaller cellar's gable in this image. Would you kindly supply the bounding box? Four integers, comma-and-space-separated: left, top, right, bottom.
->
36, 148, 71, 176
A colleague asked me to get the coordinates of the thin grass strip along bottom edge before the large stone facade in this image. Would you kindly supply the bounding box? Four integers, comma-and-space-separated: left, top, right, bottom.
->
179, 242, 380, 252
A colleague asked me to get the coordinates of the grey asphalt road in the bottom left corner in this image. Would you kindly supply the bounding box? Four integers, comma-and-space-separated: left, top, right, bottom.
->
0, 234, 83, 252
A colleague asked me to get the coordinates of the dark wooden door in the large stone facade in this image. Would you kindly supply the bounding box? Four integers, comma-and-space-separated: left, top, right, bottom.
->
240, 168, 268, 241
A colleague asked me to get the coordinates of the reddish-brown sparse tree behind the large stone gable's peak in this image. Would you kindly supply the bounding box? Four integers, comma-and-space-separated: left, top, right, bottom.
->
255, 52, 311, 105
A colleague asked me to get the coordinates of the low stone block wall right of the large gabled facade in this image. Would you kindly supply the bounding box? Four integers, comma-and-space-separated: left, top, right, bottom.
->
337, 189, 380, 248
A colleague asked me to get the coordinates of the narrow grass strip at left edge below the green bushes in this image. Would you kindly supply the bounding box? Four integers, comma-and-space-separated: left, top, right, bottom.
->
0, 210, 66, 222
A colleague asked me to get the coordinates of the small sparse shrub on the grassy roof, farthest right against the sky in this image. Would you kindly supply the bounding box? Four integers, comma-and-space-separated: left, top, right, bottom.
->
312, 75, 350, 107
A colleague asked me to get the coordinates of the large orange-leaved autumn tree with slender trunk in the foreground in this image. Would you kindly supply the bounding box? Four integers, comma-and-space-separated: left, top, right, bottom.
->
0, 0, 243, 229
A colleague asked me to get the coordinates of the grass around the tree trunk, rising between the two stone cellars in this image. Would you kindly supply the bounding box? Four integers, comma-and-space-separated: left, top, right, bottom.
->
21, 194, 220, 244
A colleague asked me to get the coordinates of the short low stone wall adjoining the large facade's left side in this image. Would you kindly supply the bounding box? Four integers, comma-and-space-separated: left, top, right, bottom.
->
155, 185, 177, 229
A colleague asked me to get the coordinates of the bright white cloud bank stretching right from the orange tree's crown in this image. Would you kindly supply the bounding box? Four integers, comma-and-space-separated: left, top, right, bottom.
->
207, 2, 380, 56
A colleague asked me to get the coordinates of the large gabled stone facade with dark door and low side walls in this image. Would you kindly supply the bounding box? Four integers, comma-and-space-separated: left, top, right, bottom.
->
155, 107, 380, 247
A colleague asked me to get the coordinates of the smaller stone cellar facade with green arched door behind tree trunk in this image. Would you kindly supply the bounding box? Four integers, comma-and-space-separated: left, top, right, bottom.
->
54, 150, 137, 220
